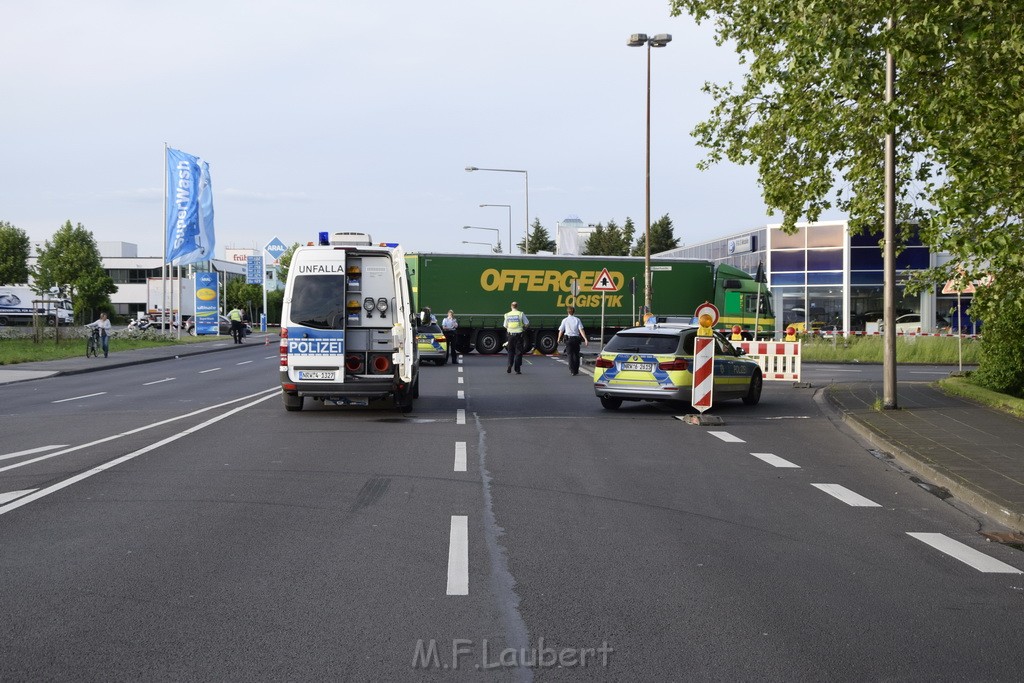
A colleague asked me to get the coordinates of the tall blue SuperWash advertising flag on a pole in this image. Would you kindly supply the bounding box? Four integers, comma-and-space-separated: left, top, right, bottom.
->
166, 147, 214, 265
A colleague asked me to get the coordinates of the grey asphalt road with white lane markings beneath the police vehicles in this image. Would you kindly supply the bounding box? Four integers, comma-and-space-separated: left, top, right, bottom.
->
0, 346, 1024, 681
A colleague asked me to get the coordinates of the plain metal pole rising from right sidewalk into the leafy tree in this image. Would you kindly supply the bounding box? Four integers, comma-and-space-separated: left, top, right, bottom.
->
882, 17, 897, 411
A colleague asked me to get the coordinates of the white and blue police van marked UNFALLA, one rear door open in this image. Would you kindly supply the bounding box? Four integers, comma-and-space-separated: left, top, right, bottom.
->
280, 232, 419, 413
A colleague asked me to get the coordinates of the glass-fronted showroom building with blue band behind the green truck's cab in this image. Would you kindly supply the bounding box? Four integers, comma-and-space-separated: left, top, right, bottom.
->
657, 221, 970, 333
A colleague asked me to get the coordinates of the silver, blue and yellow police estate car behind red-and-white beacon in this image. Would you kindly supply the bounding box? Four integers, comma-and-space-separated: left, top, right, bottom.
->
594, 324, 763, 411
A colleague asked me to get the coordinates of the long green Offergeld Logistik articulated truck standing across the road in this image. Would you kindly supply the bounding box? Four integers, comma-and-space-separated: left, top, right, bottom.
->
406, 253, 775, 353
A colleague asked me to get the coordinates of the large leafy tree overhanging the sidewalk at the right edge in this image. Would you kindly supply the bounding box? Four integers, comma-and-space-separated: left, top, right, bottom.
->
671, 0, 1024, 393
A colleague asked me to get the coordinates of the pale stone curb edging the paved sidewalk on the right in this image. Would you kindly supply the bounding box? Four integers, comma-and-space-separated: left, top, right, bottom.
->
814, 387, 1024, 532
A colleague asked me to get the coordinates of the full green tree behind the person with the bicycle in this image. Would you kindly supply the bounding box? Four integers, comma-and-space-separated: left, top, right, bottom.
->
33, 220, 118, 321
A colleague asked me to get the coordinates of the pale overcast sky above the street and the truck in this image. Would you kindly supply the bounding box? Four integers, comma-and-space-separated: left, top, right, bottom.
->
0, 0, 798, 256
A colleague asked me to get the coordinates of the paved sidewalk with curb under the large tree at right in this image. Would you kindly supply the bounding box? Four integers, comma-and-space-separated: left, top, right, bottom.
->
824, 382, 1024, 532
